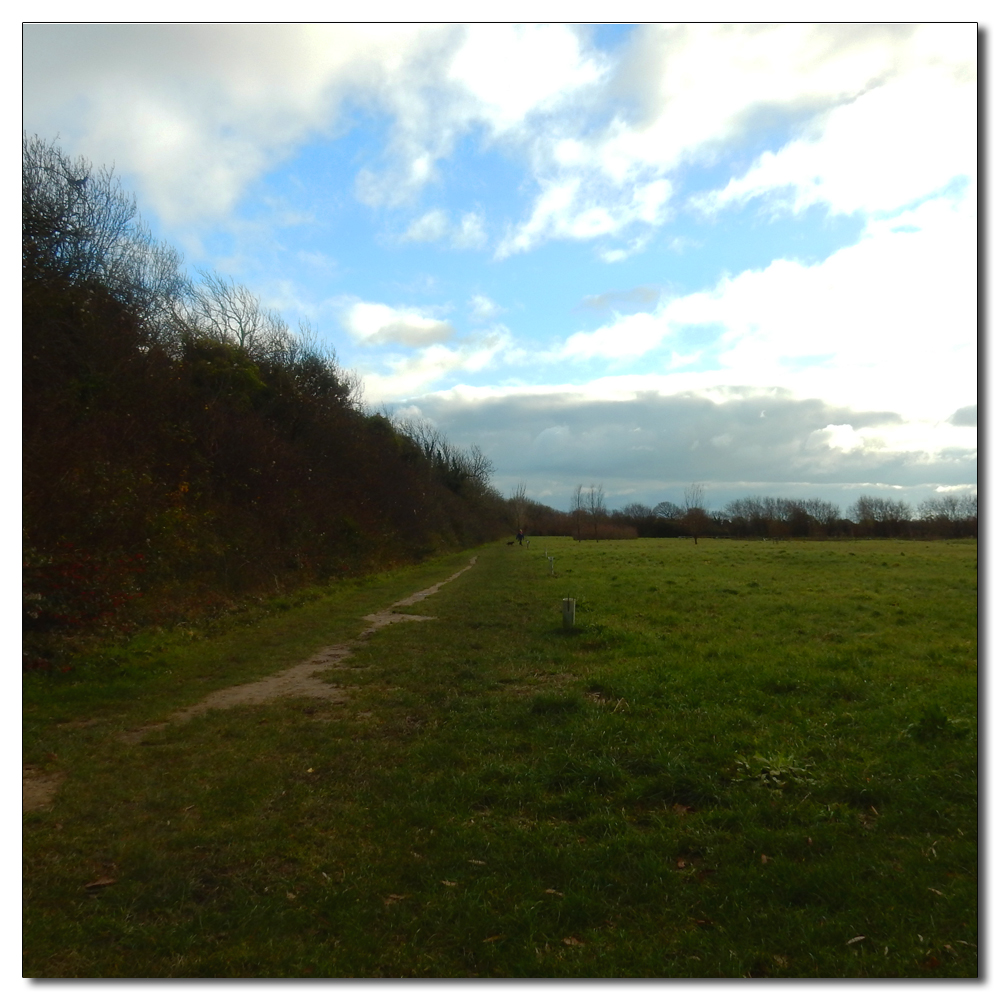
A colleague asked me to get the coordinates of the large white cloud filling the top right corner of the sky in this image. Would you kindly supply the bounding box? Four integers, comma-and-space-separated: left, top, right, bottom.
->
498, 24, 976, 262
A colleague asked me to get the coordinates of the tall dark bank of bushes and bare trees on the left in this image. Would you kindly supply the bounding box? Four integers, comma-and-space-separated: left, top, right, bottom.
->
22, 137, 510, 660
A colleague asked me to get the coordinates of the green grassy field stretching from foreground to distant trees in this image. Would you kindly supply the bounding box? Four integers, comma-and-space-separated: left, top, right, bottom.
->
23, 538, 978, 978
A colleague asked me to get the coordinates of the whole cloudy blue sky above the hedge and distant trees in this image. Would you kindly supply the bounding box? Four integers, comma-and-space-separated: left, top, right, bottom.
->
23, 22, 978, 509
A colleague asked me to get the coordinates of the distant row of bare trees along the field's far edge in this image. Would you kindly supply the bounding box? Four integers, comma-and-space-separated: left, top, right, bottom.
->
508, 487, 979, 541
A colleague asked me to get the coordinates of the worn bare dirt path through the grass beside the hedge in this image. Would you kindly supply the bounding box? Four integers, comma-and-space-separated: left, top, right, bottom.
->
21, 556, 476, 812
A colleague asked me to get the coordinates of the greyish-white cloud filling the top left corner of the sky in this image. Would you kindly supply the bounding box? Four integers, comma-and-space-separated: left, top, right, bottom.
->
24, 24, 413, 223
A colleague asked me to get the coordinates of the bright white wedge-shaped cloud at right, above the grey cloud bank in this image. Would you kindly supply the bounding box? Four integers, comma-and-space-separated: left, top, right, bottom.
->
556, 184, 977, 420
